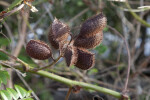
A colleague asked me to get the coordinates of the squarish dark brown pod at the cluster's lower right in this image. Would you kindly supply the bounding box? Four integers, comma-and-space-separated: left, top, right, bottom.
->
75, 48, 95, 70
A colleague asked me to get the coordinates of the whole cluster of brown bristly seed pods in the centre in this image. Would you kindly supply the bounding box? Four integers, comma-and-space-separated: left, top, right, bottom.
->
26, 13, 107, 70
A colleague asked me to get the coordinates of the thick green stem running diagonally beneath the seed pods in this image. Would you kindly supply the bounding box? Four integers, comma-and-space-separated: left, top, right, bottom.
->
0, 49, 122, 99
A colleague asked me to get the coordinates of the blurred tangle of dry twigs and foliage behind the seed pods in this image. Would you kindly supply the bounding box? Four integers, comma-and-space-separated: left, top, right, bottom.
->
0, 0, 150, 100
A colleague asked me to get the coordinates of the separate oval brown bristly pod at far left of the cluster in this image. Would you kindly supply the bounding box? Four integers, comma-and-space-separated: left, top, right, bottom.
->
26, 40, 52, 60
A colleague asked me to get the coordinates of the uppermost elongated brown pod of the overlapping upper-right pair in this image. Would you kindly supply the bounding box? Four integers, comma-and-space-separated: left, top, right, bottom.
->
79, 13, 107, 37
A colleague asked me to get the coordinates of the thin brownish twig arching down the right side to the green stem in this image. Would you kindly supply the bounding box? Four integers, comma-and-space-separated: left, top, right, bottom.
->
107, 25, 131, 95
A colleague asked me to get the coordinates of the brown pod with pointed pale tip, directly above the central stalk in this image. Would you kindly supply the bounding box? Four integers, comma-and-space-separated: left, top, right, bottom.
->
48, 18, 70, 49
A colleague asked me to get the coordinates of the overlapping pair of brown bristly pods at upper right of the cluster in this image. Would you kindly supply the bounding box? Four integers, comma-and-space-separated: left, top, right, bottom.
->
74, 13, 107, 49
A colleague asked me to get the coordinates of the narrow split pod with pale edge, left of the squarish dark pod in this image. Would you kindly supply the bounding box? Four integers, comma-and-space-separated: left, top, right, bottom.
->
64, 46, 78, 67
